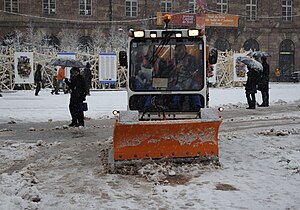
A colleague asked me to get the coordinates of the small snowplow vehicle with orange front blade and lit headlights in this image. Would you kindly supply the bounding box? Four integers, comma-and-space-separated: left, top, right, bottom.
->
111, 15, 222, 163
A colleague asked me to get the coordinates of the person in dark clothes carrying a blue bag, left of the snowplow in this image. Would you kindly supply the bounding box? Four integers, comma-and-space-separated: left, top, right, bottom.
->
65, 68, 86, 127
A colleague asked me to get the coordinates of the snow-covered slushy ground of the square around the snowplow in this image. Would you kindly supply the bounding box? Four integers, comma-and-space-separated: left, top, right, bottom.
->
0, 83, 300, 210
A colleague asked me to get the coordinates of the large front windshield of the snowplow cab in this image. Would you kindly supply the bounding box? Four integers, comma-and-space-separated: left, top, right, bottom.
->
129, 37, 204, 92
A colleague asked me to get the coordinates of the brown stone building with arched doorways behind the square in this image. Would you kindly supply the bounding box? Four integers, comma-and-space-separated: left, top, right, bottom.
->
0, 0, 300, 81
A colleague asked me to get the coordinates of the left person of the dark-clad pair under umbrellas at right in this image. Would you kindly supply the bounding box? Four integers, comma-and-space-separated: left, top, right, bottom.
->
245, 68, 259, 109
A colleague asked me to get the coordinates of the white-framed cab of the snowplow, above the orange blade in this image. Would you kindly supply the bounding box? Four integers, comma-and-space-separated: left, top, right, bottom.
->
127, 29, 207, 119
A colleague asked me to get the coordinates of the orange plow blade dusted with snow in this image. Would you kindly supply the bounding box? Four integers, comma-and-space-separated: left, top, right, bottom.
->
113, 119, 221, 161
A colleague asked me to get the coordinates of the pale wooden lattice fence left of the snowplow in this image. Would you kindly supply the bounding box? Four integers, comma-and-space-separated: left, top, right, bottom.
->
0, 46, 127, 90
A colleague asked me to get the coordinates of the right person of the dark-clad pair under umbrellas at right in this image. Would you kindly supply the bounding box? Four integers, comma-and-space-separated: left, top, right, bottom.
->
258, 57, 270, 107
